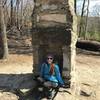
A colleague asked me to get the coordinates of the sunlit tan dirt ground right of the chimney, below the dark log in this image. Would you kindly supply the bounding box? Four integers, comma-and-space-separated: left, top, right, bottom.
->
76, 54, 100, 100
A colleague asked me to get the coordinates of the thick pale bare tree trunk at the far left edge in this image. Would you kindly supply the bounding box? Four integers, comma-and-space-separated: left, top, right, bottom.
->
0, 0, 8, 59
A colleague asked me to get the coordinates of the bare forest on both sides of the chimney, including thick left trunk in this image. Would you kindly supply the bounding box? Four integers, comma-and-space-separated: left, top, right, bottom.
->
0, 0, 100, 58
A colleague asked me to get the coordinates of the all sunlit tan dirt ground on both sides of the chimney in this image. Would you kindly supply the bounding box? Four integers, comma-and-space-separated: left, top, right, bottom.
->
0, 50, 100, 100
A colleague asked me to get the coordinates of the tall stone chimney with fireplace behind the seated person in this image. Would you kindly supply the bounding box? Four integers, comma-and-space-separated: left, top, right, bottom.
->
32, 0, 77, 88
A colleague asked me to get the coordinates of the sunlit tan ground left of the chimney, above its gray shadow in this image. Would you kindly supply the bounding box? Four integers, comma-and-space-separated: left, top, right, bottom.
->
0, 54, 33, 74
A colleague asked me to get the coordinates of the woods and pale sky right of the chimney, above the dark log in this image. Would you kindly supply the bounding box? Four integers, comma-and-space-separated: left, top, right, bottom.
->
76, 0, 100, 41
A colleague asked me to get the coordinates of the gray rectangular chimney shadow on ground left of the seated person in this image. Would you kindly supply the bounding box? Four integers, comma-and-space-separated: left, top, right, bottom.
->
0, 74, 36, 89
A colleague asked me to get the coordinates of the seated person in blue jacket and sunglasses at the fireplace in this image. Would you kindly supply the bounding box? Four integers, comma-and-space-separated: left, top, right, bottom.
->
38, 54, 64, 97
